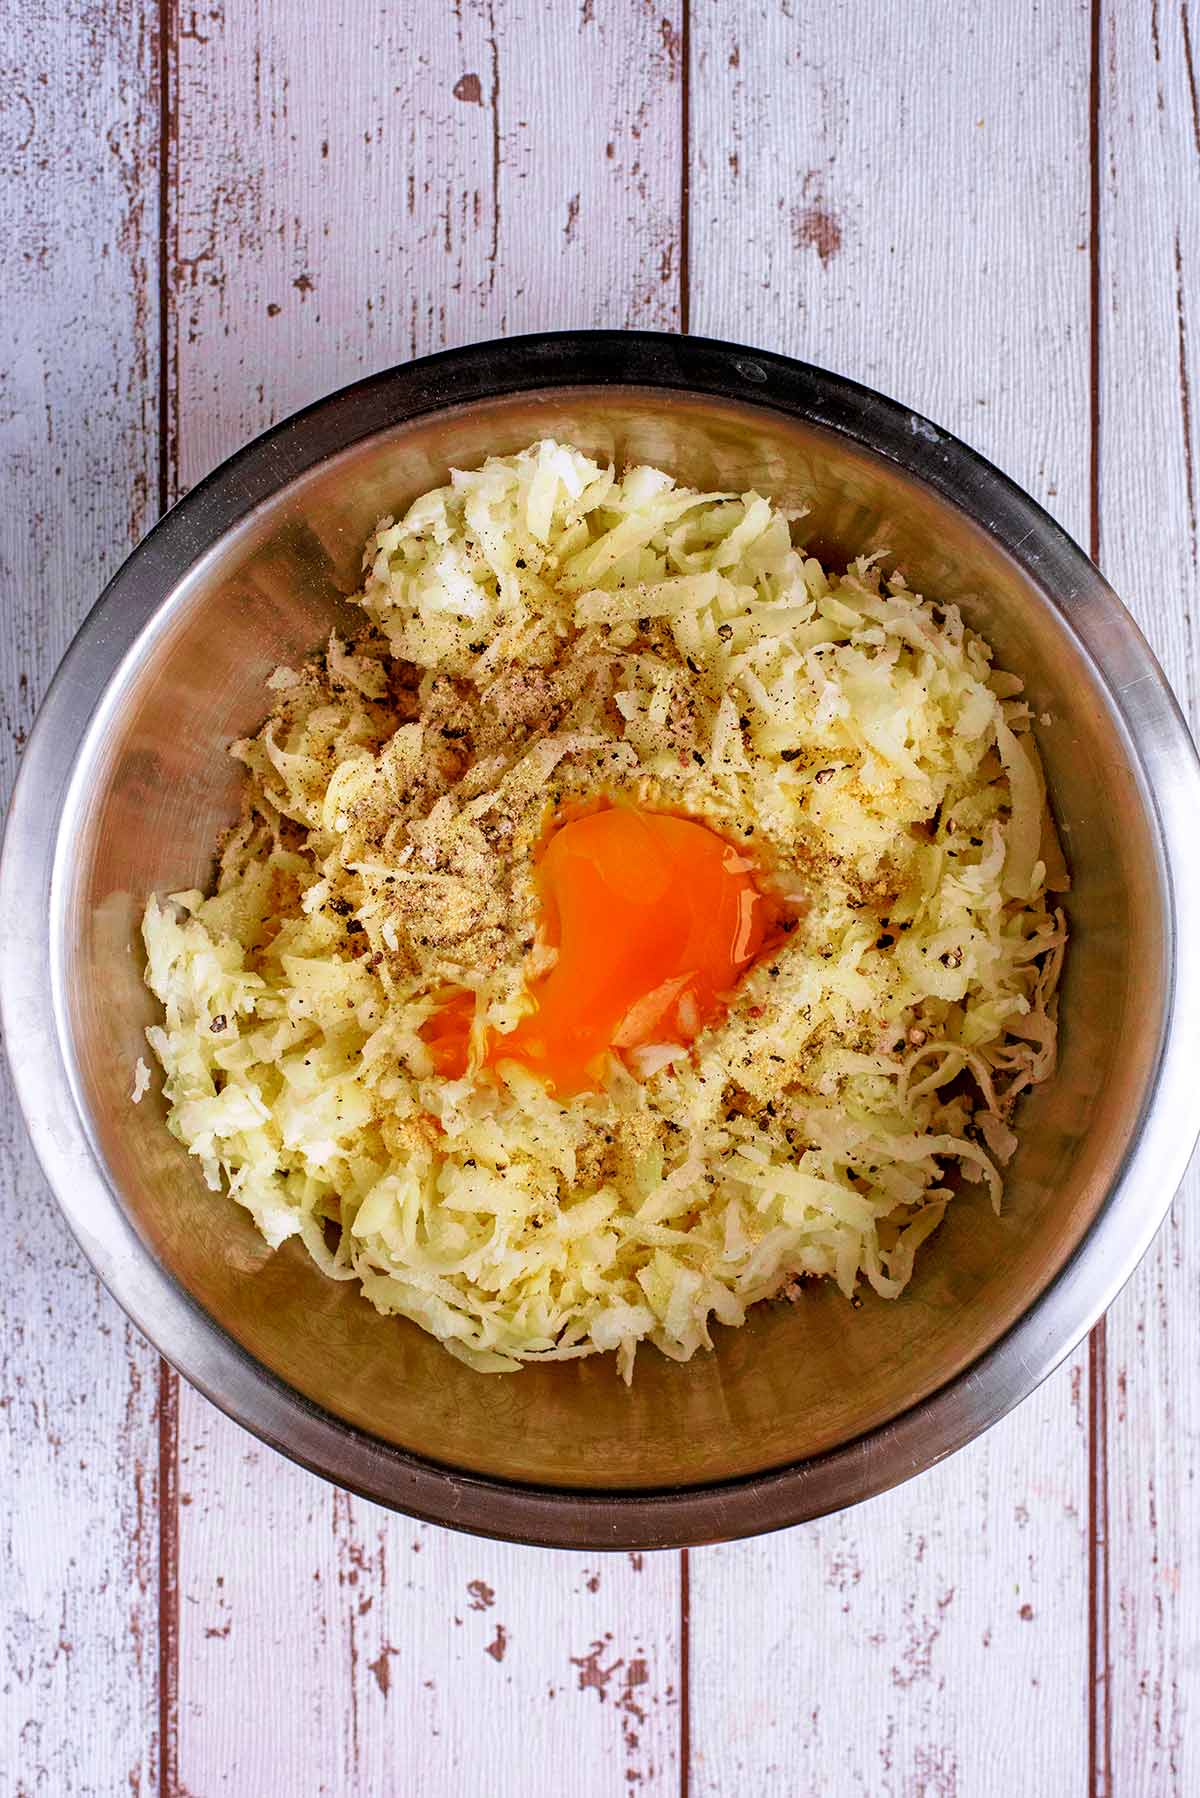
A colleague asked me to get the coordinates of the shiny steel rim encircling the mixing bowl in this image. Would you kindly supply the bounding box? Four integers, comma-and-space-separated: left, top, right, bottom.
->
0, 331, 1200, 1548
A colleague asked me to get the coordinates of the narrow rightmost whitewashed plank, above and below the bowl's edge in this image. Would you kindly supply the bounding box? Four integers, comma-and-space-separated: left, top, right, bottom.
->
1096, 0, 1200, 1798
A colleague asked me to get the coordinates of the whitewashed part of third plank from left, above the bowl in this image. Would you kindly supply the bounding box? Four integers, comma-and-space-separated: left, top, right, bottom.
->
689, 0, 1088, 538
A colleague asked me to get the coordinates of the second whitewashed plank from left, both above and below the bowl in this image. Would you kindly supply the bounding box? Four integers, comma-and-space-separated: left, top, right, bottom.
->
173, 0, 680, 1798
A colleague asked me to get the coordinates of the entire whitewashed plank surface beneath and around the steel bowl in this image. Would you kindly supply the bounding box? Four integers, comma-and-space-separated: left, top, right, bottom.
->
9, 0, 1200, 1798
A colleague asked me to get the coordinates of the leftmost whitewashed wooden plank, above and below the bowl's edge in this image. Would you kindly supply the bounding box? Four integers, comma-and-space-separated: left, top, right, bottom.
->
0, 0, 158, 1794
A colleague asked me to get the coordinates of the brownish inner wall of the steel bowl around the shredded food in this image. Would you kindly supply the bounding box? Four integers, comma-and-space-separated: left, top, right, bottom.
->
54, 388, 1166, 1489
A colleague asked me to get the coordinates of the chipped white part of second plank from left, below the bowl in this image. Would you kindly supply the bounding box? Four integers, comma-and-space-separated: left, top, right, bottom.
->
180, 1429, 678, 1798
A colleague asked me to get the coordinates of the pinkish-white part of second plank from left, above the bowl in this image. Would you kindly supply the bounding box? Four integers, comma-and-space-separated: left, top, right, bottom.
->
173, 0, 680, 487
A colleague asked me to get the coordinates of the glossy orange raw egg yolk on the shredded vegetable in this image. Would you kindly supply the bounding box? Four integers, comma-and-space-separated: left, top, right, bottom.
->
421, 806, 772, 1095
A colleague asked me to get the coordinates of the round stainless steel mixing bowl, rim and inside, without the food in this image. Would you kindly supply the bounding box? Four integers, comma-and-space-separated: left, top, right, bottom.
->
0, 333, 1200, 1546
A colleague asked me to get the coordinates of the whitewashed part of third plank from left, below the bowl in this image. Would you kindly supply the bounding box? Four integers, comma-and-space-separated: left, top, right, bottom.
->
691, 1365, 1093, 1798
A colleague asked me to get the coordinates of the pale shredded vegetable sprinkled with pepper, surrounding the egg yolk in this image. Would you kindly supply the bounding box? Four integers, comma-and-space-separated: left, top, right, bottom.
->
135, 442, 1065, 1379
